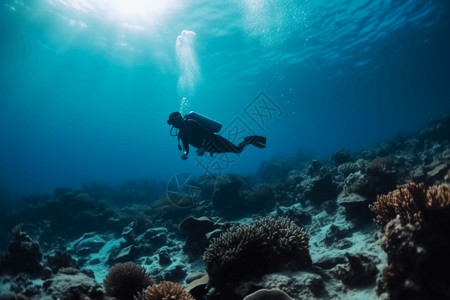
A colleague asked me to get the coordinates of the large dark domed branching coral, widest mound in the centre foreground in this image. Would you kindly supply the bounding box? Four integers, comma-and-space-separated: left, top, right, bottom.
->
203, 218, 311, 285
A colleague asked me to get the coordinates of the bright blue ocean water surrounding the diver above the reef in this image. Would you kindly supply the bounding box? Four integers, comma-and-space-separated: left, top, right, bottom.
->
0, 0, 450, 199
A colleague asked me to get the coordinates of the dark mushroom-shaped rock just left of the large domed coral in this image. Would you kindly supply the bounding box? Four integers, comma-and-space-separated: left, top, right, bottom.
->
179, 217, 216, 260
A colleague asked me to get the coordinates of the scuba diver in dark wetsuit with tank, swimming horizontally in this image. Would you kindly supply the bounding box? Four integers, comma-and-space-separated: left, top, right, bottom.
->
167, 111, 266, 160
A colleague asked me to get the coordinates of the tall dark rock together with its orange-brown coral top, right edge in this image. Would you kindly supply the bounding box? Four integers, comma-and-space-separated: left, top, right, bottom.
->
371, 183, 450, 300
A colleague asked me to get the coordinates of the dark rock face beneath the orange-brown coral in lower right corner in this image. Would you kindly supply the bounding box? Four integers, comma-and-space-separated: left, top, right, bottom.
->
381, 219, 450, 299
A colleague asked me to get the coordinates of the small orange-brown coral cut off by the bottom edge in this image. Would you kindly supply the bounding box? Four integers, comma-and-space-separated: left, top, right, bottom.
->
145, 281, 195, 300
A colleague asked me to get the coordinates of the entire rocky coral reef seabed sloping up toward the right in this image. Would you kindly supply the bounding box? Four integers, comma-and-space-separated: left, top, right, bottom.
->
0, 118, 450, 300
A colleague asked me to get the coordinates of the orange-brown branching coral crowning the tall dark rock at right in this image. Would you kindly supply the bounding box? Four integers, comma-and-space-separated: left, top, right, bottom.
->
369, 182, 450, 227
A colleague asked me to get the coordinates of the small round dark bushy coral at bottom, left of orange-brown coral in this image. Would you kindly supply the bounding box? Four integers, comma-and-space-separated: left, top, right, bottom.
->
104, 262, 152, 300
